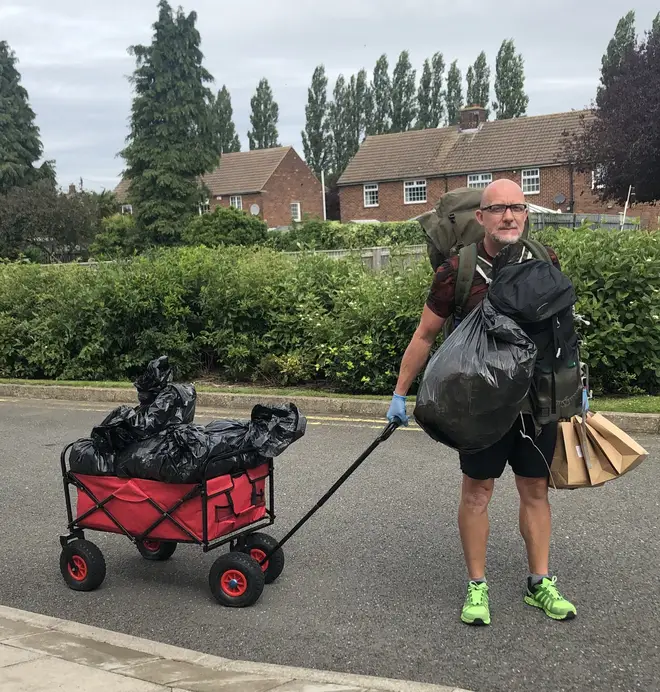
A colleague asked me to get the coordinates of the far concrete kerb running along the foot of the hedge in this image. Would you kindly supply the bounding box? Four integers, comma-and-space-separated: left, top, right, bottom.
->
0, 384, 660, 435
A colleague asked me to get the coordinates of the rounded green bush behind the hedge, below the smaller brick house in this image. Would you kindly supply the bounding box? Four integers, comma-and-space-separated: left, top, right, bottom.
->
182, 206, 268, 247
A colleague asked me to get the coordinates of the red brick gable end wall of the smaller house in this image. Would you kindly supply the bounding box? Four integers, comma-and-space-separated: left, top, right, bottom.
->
263, 149, 323, 228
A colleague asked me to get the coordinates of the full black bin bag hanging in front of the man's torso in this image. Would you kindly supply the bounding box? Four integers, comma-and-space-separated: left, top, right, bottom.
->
413, 298, 536, 454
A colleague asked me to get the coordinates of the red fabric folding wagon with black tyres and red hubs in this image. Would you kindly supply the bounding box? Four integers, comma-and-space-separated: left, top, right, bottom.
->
60, 444, 284, 607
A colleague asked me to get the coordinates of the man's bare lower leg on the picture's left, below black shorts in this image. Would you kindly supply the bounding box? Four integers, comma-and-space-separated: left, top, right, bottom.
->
458, 475, 495, 579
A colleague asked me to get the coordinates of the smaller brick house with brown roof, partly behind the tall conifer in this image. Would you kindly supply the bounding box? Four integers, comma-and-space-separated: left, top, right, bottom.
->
115, 147, 323, 228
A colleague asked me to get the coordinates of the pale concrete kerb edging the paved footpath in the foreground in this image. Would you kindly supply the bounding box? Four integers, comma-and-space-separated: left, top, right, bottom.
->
0, 605, 469, 692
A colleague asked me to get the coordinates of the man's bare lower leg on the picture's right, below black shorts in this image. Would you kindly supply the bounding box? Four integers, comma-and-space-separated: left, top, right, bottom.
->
516, 476, 551, 574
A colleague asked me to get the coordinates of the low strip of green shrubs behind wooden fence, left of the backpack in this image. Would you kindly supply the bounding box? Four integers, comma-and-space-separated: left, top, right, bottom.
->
268, 220, 426, 252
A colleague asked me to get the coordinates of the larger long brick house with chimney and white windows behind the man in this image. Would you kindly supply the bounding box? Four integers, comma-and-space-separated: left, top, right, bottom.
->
338, 107, 660, 225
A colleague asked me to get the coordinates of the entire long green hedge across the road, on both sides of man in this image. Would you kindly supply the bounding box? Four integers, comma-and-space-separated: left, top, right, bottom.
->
0, 230, 660, 394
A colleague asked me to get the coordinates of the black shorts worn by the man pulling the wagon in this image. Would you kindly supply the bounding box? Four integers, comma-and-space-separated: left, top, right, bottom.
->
460, 415, 558, 481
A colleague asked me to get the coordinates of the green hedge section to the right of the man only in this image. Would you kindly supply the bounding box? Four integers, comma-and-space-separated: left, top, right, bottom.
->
536, 228, 660, 394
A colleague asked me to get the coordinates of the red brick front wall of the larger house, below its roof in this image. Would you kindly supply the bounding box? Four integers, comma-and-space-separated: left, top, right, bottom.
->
339, 166, 660, 228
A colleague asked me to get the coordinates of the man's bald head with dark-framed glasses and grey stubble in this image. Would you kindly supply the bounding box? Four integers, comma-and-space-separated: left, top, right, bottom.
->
477, 178, 527, 247
